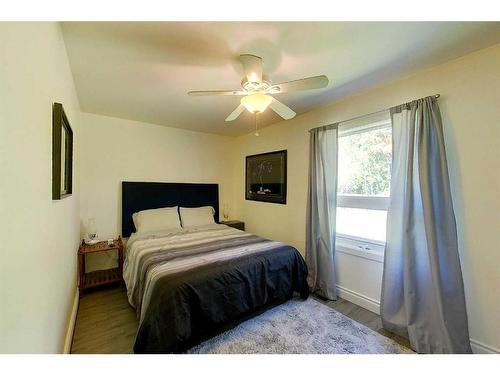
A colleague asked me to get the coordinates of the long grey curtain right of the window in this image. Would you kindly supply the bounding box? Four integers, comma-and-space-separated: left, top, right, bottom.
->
381, 97, 471, 353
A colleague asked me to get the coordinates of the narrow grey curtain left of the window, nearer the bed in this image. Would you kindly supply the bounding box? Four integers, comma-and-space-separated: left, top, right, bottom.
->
306, 124, 337, 300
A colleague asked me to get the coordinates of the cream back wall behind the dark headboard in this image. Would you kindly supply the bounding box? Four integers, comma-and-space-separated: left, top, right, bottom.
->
81, 113, 234, 269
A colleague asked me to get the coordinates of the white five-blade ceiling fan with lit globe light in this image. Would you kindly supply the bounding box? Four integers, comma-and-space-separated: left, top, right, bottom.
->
188, 54, 328, 121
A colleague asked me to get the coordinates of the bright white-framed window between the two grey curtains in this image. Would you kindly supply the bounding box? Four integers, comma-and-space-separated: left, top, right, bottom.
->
337, 113, 392, 252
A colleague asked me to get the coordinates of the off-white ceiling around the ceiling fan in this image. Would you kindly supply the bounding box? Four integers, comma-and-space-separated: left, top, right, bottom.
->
63, 22, 500, 135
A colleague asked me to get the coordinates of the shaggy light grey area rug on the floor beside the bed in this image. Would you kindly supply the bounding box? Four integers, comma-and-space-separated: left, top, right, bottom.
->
188, 298, 413, 354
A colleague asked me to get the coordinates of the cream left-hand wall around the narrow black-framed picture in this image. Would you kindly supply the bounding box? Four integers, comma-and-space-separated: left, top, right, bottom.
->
0, 23, 80, 353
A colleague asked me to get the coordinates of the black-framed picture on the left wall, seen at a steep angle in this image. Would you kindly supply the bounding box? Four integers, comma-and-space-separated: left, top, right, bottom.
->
52, 103, 73, 200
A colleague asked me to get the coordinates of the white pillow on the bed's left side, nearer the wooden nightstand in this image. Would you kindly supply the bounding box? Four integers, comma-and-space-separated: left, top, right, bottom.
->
132, 206, 181, 233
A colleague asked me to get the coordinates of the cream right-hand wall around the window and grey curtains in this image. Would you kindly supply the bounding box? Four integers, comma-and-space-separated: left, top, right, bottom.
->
233, 45, 500, 351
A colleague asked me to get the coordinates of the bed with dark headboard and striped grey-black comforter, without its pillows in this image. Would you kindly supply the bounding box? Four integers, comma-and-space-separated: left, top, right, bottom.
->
122, 182, 309, 353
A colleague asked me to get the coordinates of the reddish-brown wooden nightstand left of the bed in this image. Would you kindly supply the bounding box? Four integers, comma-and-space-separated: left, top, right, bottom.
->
78, 237, 123, 293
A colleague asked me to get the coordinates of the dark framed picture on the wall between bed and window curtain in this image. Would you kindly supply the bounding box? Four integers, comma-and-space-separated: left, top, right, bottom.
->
245, 150, 287, 204
